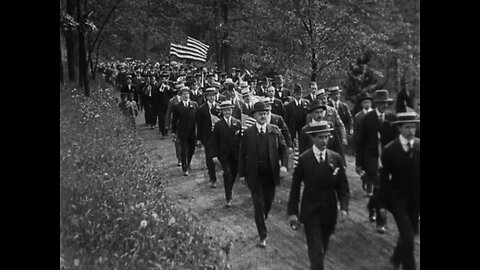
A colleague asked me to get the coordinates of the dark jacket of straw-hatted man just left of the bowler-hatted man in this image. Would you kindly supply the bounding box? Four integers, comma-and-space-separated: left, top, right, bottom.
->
212, 117, 242, 162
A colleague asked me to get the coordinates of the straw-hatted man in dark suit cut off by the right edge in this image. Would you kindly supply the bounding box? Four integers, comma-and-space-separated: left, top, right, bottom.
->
379, 112, 420, 270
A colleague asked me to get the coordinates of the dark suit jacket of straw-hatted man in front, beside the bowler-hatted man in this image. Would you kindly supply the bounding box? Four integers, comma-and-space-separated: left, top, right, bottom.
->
287, 148, 350, 225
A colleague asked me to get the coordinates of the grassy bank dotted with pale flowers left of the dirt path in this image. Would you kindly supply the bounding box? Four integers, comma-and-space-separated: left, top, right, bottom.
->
60, 83, 225, 269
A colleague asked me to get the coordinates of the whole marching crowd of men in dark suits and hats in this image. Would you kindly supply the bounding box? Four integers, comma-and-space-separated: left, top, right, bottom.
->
100, 61, 420, 269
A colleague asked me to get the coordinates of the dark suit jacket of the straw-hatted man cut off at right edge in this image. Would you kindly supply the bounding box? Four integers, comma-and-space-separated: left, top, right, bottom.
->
379, 138, 420, 225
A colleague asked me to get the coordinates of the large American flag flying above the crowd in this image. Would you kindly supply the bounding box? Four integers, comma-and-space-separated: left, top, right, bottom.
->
170, 30, 210, 62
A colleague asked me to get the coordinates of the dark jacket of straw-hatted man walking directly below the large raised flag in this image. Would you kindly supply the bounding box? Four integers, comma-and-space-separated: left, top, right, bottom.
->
172, 100, 198, 140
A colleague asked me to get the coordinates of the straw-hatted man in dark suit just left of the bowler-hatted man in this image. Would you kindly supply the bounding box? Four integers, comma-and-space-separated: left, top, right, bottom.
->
212, 100, 242, 207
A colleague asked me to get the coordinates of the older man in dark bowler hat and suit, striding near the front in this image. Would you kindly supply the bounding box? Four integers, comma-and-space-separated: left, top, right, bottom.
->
238, 101, 288, 248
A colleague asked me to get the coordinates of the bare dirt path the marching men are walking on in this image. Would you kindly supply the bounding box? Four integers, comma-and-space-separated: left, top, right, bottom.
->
133, 113, 420, 270
